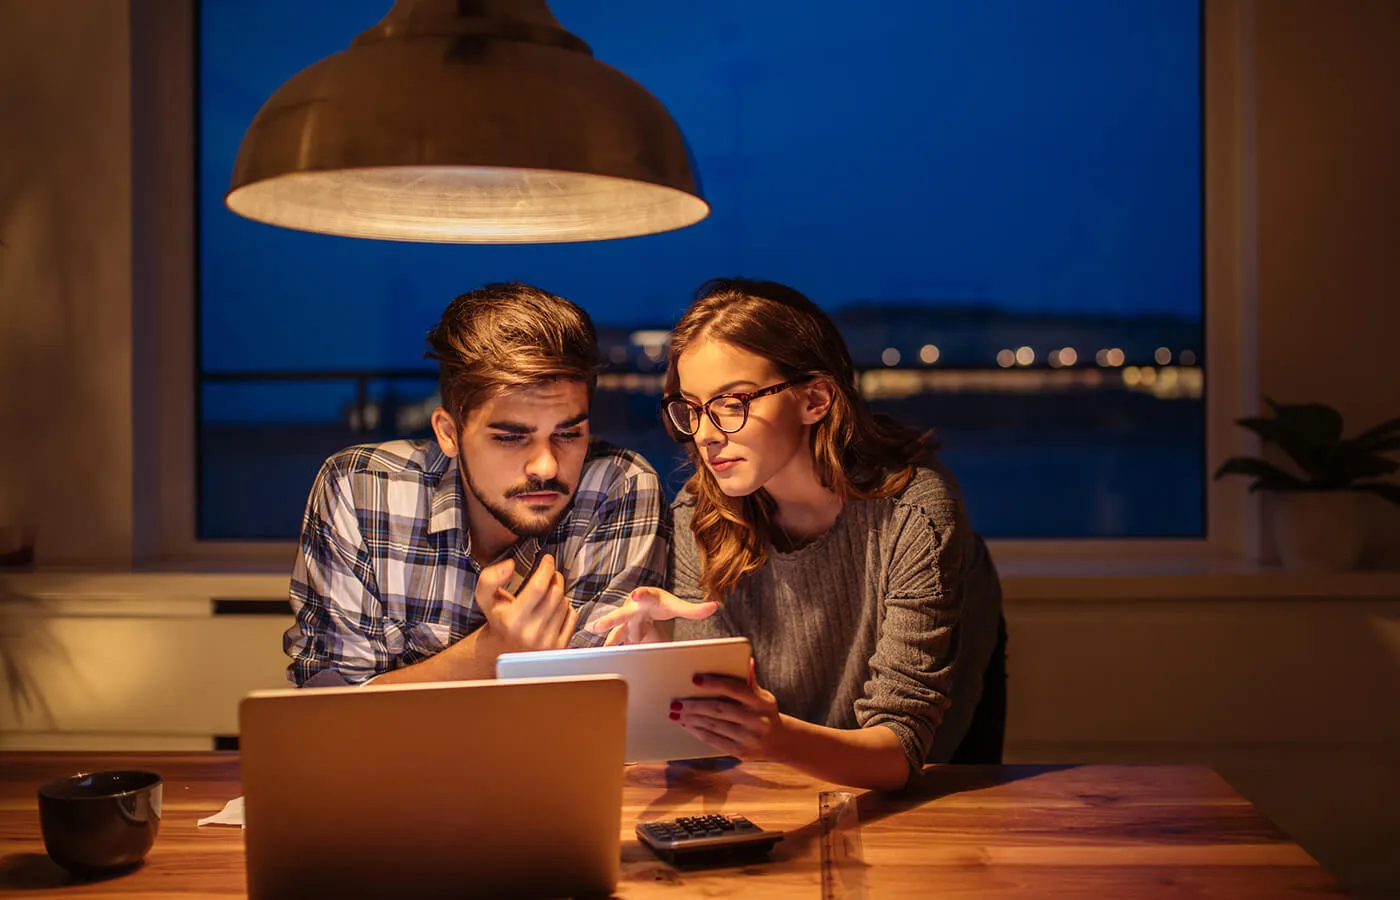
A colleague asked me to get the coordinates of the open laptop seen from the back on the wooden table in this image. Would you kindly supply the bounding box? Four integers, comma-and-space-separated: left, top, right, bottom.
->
238, 676, 627, 900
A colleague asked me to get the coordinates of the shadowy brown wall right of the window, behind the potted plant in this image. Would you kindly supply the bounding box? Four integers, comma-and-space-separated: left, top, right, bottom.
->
1254, 0, 1400, 565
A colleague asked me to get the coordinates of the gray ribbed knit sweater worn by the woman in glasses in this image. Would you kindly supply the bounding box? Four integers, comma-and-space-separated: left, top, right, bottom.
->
671, 460, 1001, 768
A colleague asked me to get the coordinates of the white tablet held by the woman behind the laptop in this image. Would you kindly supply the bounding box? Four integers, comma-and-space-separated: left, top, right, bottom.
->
496, 637, 753, 763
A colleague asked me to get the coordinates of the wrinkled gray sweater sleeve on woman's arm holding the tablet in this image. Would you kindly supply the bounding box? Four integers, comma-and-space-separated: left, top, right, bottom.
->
855, 478, 973, 771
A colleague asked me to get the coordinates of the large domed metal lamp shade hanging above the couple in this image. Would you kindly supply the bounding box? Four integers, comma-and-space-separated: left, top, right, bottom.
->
225, 0, 710, 244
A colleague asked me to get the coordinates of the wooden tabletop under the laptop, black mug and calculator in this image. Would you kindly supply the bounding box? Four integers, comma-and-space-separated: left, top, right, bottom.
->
0, 753, 1344, 900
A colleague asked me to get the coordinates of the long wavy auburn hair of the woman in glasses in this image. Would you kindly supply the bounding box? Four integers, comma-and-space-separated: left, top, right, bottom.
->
662, 279, 932, 599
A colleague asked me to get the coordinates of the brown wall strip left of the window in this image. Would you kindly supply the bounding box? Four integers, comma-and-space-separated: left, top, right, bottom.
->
0, 0, 133, 564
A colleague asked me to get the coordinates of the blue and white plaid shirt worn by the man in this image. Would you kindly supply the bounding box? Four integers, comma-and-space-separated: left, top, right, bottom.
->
283, 440, 671, 687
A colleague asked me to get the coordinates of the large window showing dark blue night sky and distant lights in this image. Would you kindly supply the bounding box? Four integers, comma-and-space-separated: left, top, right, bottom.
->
197, 0, 1205, 539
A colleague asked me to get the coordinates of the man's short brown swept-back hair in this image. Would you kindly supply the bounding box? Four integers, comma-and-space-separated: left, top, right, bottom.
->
424, 281, 598, 428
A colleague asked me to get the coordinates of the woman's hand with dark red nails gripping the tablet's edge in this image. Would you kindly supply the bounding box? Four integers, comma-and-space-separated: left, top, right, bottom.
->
671, 658, 785, 760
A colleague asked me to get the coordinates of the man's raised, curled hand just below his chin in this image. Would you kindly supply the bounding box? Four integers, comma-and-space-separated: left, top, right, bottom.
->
476, 553, 578, 649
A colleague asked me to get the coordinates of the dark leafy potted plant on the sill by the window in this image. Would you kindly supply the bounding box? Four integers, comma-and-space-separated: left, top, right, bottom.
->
1215, 398, 1400, 571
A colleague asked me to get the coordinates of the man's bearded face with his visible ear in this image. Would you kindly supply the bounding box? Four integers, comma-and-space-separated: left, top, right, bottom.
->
433, 381, 588, 537
